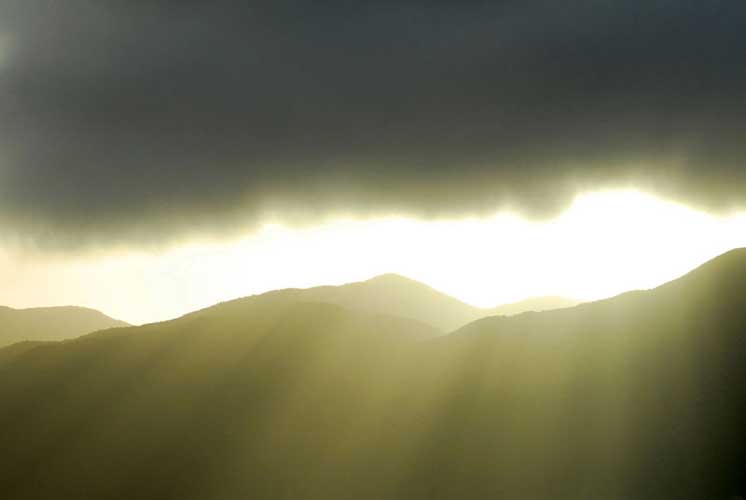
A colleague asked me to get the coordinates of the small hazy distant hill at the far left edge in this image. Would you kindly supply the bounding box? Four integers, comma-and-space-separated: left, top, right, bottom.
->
0, 306, 129, 347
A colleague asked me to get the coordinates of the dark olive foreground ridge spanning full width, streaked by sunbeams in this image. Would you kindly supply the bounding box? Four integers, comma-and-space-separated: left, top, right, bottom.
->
0, 250, 746, 500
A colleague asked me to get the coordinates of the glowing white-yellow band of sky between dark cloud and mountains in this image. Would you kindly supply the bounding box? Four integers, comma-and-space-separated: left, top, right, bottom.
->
0, 190, 746, 322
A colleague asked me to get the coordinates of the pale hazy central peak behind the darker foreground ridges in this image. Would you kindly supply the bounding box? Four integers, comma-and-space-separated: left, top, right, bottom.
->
239, 274, 579, 332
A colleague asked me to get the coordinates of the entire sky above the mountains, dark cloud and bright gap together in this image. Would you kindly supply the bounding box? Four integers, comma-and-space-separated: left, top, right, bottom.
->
0, 0, 746, 322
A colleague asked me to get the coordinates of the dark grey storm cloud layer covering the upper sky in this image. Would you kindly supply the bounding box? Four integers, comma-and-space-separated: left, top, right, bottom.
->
0, 0, 746, 247
